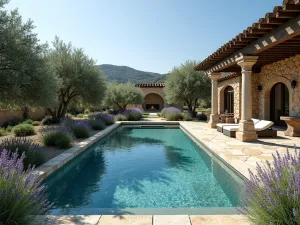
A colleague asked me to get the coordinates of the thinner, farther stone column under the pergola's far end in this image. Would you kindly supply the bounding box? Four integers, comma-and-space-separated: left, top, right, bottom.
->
208, 73, 221, 128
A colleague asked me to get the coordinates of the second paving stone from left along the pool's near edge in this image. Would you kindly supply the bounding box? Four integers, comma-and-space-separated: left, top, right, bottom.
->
98, 215, 152, 225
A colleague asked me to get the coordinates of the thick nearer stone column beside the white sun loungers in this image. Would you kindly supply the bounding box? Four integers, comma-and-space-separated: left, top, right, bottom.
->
236, 56, 258, 141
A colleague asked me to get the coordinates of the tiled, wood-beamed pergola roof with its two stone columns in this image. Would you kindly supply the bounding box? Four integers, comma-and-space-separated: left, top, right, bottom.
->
195, 0, 300, 141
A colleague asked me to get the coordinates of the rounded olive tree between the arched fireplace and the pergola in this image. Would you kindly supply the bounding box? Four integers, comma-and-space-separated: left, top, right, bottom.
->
165, 61, 211, 115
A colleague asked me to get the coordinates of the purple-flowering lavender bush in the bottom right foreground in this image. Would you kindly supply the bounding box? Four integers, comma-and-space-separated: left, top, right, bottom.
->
243, 147, 300, 225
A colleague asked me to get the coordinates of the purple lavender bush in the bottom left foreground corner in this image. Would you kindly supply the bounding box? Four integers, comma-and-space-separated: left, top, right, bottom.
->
0, 149, 51, 225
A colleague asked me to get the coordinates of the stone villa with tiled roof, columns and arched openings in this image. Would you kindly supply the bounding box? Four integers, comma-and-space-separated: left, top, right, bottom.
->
195, 0, 300, 141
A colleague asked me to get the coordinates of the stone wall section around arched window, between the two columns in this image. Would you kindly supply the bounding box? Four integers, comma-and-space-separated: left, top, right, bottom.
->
218, 77, 241, 119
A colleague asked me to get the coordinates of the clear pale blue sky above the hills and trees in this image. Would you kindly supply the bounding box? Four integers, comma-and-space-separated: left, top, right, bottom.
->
6, 0, 282, 73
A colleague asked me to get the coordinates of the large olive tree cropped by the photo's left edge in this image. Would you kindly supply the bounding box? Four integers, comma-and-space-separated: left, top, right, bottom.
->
0, 0, 57, 109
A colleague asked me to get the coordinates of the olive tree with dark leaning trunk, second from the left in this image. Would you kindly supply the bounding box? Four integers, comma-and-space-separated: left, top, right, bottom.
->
48, 37, 106, 119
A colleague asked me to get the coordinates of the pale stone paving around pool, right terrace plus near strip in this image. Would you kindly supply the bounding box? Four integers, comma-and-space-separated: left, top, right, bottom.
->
34, 118, 300, 225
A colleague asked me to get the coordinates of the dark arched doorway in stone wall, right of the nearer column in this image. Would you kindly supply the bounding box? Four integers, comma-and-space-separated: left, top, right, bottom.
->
270, 82, 289, 125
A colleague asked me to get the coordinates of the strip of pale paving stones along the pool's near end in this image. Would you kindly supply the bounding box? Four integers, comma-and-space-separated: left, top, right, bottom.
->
34, 215, 248, 225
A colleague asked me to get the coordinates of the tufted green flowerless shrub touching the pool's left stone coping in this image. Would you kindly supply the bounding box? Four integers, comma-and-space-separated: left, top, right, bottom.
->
41, 126, 73, 149
